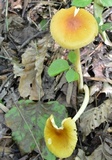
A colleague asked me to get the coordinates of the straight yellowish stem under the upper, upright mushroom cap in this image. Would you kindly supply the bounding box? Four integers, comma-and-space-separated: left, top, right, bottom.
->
74, 49, 83, 91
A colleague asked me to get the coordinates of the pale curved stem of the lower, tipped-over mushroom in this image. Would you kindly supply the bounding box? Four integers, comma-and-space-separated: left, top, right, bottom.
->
73, 85, 89, 121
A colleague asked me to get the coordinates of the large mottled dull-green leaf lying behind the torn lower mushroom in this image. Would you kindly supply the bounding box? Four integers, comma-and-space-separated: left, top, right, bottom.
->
5, 100, 67, 160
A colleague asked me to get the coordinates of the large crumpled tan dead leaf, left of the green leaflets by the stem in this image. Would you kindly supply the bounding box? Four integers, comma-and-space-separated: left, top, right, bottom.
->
13, 39, 47, 100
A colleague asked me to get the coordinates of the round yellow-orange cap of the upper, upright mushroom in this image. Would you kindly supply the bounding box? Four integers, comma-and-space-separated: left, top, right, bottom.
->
50, 7, 98, 49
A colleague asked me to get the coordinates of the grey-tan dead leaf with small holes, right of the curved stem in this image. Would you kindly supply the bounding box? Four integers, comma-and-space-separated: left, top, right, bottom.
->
80, 99, 112, 136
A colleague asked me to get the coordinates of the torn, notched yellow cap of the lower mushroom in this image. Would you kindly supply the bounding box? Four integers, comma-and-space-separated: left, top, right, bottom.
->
44, 115, 77, 158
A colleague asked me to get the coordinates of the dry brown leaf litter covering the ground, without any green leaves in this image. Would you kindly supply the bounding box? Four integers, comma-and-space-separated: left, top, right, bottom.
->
0, 0, 112, 160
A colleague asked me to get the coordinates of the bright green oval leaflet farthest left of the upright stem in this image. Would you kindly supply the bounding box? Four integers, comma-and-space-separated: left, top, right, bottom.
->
48, 59, 69, 77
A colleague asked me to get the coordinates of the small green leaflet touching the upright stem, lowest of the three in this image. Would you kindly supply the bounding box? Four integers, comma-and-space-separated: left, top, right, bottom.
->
65, 69, 79, 82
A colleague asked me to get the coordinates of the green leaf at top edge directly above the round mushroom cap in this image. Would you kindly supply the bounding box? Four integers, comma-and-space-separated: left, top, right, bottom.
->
71, 0, 92, 7
